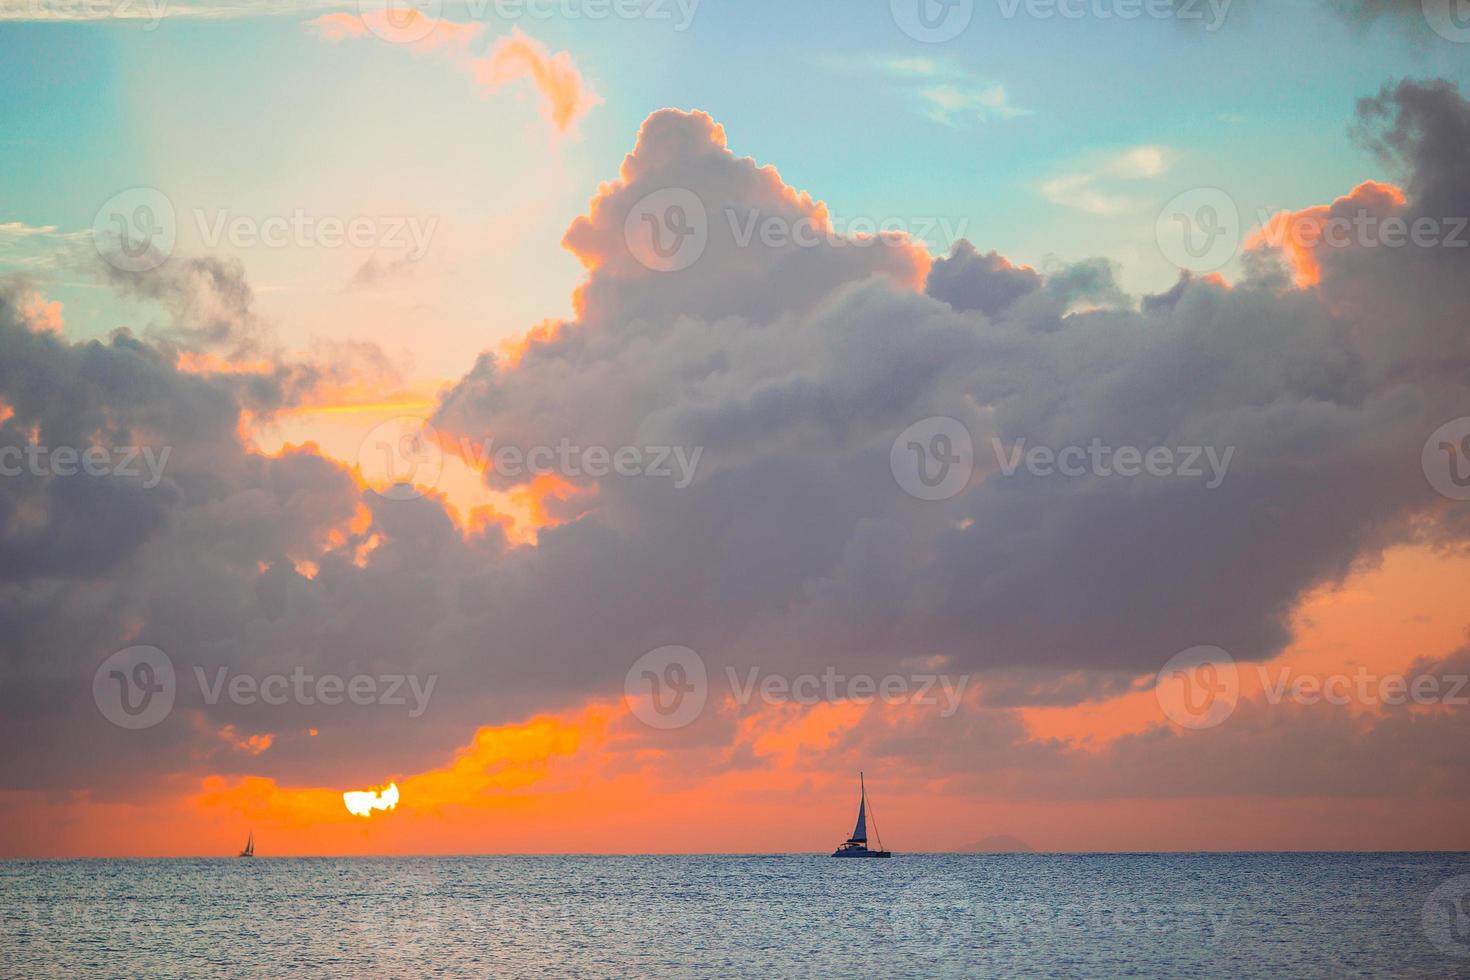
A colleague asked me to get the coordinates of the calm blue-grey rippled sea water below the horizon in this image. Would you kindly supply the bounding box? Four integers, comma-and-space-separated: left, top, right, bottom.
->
0, 854, 1470, 977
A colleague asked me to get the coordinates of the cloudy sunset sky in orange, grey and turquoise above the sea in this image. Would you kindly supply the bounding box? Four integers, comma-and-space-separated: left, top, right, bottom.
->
0, 0, 1470, 857
